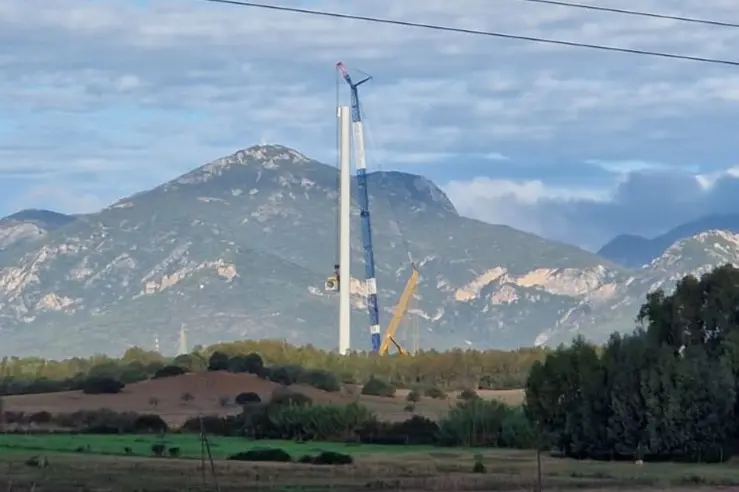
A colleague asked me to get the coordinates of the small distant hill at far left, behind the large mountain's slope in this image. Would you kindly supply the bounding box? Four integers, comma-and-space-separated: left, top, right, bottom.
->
0, 209, 75, 250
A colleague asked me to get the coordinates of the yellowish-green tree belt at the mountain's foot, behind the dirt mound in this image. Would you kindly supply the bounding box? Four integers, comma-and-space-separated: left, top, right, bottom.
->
0, 340, 547, 394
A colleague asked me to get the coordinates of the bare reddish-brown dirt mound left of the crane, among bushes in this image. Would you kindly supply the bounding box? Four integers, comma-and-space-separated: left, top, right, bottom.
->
4, 372, 352, 426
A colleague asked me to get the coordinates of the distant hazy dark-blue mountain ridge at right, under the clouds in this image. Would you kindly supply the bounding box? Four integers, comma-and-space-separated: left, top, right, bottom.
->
598, 214, 739, 268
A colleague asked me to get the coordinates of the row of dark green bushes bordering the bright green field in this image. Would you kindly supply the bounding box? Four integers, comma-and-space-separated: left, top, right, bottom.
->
2, 387, 534, 449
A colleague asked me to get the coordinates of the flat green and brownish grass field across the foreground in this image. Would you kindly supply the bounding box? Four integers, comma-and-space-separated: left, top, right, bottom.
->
0, 435, 739, 492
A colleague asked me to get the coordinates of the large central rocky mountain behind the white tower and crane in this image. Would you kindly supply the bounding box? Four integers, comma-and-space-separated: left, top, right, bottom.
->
0, 145, 629, 357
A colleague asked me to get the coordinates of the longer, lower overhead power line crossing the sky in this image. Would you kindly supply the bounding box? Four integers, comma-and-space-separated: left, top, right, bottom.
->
201, 0, 739, 67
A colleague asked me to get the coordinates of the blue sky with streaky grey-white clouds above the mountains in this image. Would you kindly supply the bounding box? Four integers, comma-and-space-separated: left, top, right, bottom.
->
0, 0, 739, 249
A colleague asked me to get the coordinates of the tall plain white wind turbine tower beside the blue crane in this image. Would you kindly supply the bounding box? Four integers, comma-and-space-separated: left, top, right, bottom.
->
338, 106, 352, 354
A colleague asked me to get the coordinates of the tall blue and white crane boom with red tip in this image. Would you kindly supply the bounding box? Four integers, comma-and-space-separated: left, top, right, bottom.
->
336, 62, 382, 352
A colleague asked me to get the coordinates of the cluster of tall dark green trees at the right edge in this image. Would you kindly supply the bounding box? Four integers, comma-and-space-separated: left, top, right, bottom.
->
525, 265, 739, 462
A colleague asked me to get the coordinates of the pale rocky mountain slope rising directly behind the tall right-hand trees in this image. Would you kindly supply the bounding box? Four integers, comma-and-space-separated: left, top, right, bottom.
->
538, 230, 739, 344
